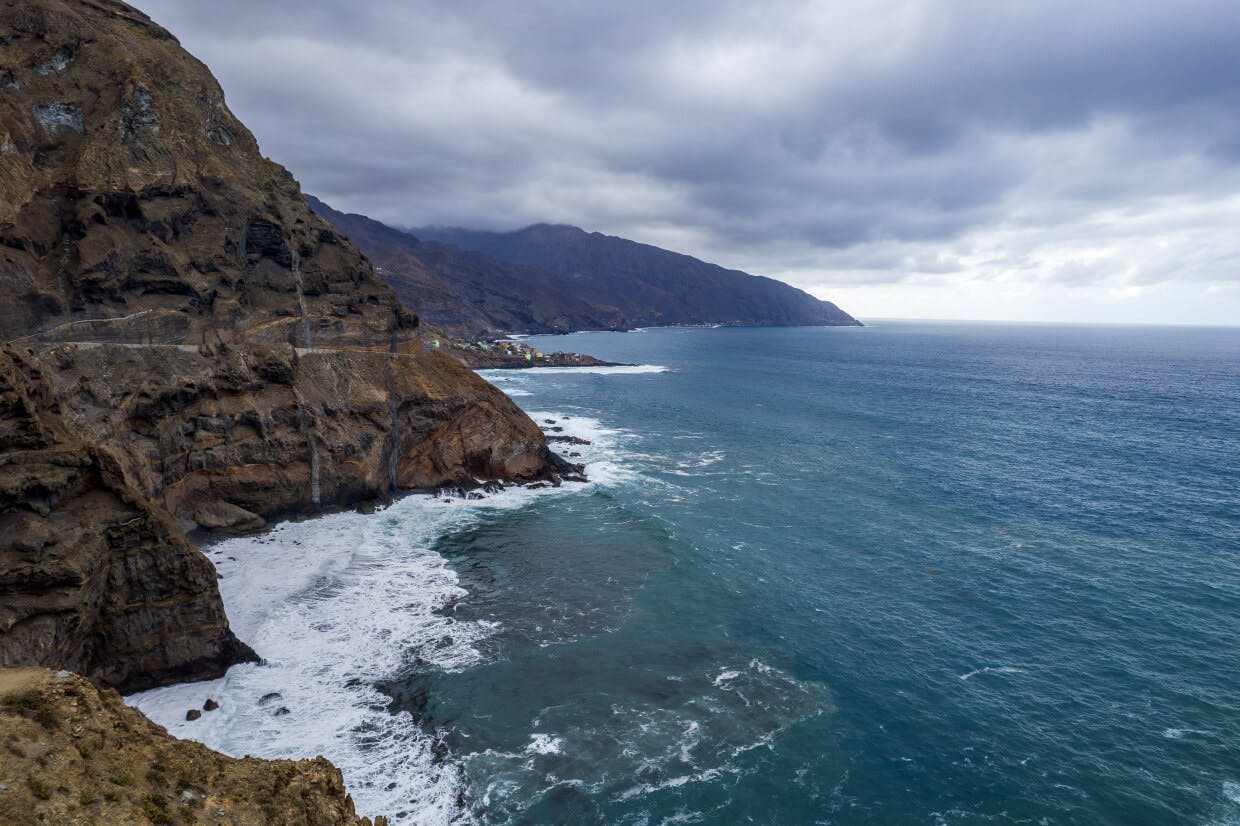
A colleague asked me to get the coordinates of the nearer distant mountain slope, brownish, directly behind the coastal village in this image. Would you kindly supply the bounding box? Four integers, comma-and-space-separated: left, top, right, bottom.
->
306, 196, 631, 336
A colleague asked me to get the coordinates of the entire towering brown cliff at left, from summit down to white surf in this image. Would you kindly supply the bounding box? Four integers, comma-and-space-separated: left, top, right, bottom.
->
0, 0, 568, 688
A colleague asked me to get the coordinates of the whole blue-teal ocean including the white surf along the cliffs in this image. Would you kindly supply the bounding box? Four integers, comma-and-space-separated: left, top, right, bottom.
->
128, 321, 1240, 826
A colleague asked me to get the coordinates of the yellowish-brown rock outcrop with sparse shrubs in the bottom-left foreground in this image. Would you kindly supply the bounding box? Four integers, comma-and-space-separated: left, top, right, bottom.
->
0, 668, 386, 826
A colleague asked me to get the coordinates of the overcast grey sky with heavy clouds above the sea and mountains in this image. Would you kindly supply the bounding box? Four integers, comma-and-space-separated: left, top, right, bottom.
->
139, 0, 1240, 324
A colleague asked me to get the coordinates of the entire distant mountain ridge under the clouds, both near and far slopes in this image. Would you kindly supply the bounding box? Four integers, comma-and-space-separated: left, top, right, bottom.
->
308, 196, 861, 336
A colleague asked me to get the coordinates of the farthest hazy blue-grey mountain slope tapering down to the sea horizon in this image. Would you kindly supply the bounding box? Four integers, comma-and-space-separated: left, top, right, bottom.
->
416, 223, 859, 326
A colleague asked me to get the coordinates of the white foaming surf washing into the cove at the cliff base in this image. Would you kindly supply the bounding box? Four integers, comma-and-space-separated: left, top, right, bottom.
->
124, 409, 629, 826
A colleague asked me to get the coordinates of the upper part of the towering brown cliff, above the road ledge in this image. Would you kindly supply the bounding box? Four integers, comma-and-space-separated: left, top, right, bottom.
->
0, 0, 415, 346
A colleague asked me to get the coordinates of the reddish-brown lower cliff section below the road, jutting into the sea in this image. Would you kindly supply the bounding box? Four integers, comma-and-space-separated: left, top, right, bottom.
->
33, 345, 569, 531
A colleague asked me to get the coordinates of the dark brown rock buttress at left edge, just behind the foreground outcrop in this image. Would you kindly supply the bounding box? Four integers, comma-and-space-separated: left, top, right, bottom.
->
0, 347, 254, 690
